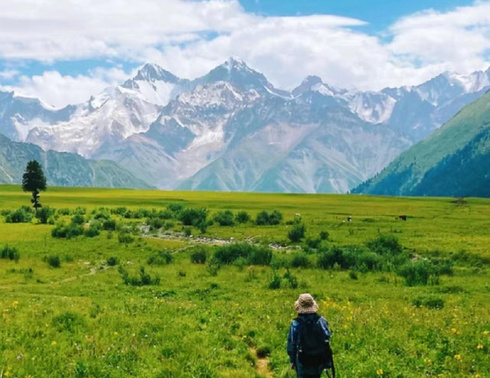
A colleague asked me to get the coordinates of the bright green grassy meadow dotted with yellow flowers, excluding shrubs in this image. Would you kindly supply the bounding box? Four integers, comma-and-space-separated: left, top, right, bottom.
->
0, 186, 490, 377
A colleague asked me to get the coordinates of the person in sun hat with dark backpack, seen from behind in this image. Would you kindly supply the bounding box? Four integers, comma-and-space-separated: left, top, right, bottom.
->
287, 293, 335, 378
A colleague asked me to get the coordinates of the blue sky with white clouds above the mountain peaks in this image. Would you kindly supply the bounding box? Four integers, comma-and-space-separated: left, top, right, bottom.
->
0, 0, 490, 107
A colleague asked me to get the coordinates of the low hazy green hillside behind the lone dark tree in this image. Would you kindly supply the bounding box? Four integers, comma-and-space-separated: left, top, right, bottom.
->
0, 134, 150, 189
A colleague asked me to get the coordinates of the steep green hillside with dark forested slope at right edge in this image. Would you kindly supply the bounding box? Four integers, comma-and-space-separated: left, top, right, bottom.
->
353, 93, 490, 197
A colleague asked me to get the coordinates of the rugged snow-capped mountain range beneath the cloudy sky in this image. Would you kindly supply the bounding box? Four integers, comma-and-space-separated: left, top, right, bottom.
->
0, 58, 490, 192
